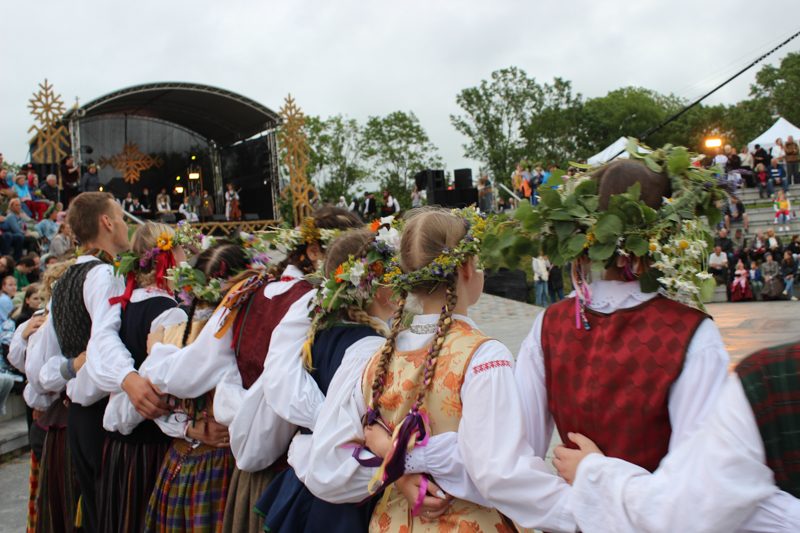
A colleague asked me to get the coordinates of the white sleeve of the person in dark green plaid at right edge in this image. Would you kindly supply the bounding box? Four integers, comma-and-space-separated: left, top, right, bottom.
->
571, 375, 800, 533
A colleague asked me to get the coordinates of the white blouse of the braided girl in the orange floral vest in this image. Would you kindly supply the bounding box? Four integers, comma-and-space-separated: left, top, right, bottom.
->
300, 315, 576, 531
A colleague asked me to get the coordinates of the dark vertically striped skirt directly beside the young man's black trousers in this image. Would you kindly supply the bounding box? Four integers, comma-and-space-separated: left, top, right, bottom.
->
97, 438, 169, 533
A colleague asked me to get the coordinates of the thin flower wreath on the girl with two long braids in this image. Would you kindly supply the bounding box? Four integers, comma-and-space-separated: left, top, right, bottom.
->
384, 206, 486, 293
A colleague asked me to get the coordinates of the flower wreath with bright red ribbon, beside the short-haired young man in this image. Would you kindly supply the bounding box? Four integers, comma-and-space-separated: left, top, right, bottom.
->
109, 232, 175, 310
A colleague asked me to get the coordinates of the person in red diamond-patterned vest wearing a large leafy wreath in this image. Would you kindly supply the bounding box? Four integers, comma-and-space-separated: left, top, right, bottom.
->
490, 148, 729, 526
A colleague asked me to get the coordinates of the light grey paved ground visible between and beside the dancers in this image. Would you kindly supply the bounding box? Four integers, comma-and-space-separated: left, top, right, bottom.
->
0, 294, 800, 533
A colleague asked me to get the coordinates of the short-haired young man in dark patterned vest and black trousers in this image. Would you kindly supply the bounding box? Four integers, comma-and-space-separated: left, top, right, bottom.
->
37, 192, 167, 533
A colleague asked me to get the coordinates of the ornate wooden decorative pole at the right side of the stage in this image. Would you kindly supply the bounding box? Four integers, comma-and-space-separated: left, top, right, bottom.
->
278, 94, 317, 225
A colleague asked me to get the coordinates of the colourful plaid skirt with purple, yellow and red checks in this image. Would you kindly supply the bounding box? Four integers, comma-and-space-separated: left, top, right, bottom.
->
145, 439, 234, 533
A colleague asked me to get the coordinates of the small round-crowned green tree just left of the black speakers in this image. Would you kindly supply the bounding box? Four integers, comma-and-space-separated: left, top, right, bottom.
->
363, 111, 444, 207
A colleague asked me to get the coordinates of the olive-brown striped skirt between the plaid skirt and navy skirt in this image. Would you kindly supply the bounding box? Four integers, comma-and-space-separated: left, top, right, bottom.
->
222, 462, 286, 533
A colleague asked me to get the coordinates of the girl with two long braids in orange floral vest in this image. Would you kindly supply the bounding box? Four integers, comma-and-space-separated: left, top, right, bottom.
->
302, 209, 575, 532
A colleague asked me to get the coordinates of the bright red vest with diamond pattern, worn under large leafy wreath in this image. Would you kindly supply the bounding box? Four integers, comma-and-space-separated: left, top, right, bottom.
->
542, 296, 707, 472
